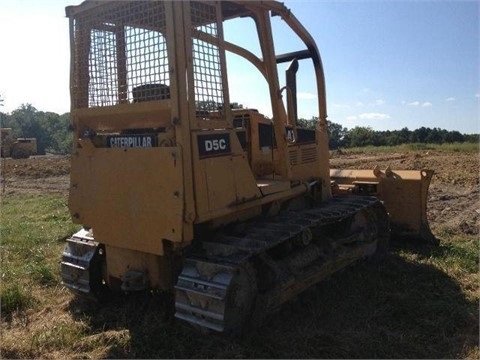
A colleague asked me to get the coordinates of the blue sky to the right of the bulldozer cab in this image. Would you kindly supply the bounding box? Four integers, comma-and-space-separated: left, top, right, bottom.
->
290, 1, 480, 133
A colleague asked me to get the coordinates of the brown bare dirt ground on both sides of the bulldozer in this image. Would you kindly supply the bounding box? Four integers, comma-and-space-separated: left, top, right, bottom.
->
1, 151, 480, 234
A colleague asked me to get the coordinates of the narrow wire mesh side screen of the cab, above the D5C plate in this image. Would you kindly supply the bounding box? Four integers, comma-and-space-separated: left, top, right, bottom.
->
191, 3, 223, 110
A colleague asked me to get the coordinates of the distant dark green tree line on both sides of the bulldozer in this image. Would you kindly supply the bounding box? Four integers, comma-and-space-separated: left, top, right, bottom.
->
0, 104, 479, 154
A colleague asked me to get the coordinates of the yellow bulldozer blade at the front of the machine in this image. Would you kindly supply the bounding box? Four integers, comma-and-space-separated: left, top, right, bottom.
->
330, 167, 438, 245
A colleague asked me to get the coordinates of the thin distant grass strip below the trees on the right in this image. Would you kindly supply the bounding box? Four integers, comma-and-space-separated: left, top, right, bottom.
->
342, 143, 480, 154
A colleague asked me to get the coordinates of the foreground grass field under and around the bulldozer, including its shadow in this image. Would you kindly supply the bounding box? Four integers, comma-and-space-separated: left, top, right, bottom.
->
0, 194, 480, 359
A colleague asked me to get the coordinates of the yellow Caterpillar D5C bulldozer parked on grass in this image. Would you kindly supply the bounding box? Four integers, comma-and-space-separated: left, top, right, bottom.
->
61, 0, 431, 332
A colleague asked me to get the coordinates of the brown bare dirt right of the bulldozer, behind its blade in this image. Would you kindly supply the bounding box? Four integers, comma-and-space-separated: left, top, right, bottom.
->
331, 151, 480, 234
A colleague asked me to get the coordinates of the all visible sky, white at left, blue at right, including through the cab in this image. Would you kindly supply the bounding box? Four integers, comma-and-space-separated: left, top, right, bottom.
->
0, 0, 480, 133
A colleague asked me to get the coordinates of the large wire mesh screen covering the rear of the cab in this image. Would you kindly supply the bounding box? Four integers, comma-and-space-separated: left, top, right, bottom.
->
73, 1, 170, 108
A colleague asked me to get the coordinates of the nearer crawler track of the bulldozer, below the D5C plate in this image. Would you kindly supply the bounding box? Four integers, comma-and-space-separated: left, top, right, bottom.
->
175, 196, 389, 332
